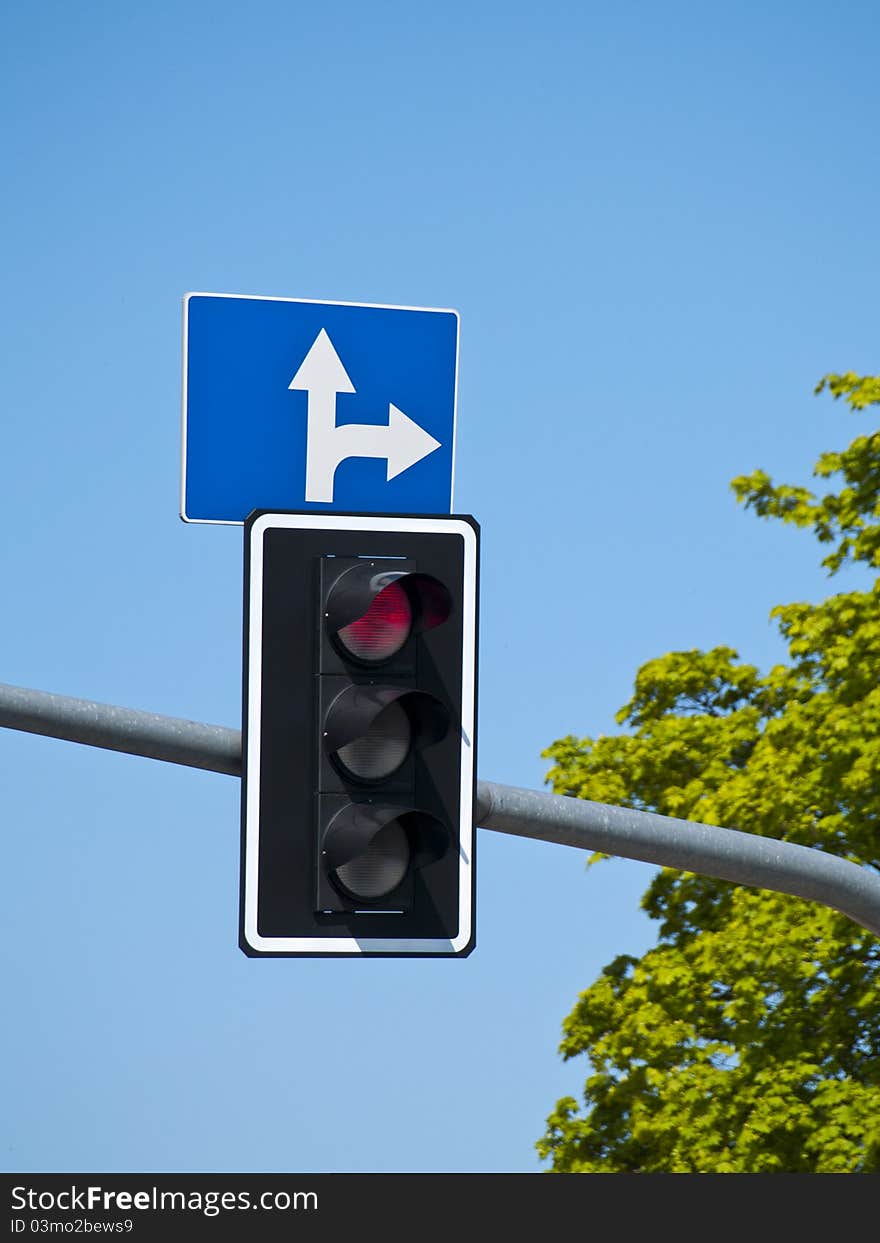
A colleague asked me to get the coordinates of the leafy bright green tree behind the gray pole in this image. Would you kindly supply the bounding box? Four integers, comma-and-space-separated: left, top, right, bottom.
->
537, 373, 880, 1173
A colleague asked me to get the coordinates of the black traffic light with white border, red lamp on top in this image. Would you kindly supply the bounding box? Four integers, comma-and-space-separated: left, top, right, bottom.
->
240, 511, 479, 957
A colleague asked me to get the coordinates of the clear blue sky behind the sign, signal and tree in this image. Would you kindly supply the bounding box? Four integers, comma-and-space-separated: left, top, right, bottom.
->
0, 0, 880, 1172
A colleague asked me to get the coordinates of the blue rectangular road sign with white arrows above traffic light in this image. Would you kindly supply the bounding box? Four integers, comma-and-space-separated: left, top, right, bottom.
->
180, 293, 459, 522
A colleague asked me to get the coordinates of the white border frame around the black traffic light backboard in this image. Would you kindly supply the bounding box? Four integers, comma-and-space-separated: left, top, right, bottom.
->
244, 512, 477, 957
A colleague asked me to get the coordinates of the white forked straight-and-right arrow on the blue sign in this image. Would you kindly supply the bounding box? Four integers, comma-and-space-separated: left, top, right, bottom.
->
287, 328, 440, 501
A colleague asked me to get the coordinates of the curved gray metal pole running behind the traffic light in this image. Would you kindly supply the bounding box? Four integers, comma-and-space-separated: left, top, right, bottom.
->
0, 684, 880, 936
